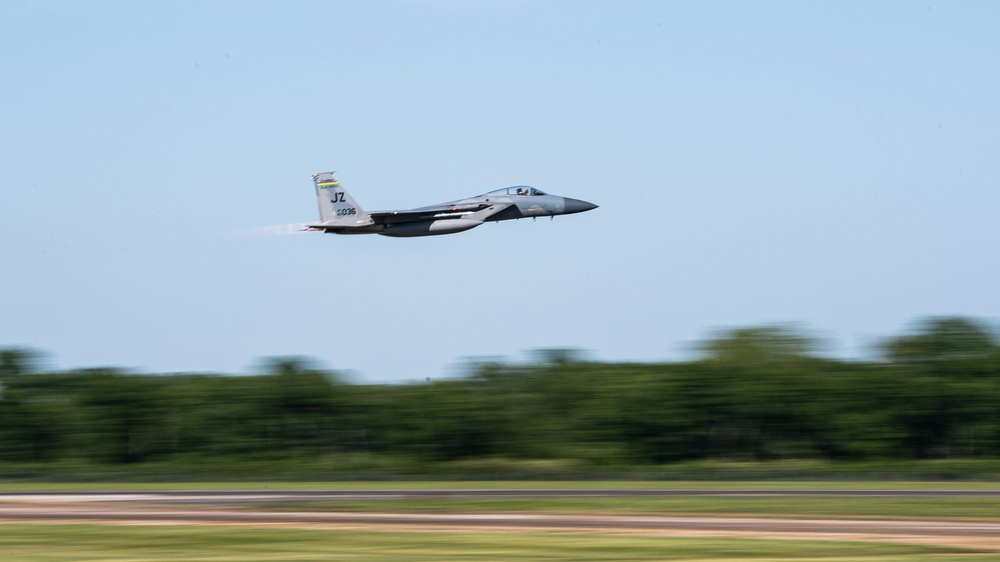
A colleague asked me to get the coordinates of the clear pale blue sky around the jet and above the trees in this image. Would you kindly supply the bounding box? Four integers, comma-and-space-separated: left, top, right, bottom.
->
0, 1, 1000, 381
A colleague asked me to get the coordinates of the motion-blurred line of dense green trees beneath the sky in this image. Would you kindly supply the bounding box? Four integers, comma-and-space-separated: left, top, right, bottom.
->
0, 318, 1000, 465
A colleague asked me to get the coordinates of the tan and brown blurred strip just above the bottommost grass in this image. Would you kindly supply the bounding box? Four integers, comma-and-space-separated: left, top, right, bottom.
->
0, 501, 1000, 552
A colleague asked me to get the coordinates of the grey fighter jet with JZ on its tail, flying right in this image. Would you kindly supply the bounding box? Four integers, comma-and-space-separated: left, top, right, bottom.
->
303, 168, 597, 237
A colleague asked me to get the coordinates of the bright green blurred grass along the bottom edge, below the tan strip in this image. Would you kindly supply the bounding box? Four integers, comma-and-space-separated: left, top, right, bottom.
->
0, 524, 1000, 562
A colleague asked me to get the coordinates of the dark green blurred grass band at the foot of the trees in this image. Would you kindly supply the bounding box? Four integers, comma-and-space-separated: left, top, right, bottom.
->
0, 453, 1000, 486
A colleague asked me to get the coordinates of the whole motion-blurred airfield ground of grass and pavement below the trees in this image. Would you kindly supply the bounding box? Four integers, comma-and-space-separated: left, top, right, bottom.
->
0, 483, 1000, 562
